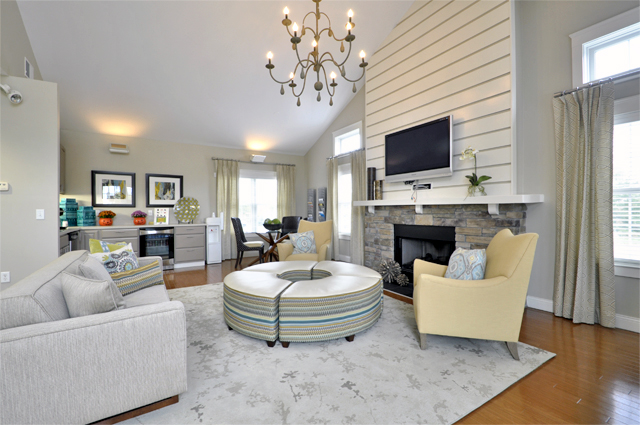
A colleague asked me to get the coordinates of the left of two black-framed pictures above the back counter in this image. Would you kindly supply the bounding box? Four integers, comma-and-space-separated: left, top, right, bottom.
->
91, 170, 136, 208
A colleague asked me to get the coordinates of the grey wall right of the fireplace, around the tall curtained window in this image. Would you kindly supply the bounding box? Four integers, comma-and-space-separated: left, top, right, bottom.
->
515, 1, 640, 317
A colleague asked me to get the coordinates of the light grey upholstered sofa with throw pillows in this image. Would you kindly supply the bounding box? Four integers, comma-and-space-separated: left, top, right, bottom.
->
0, 251, 187, 424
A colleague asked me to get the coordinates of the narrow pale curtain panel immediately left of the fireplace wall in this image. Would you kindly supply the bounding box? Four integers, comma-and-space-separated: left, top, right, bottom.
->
350, 150, 367, 265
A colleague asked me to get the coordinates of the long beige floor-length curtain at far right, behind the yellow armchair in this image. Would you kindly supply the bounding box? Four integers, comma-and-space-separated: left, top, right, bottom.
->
553, 82, 616, 328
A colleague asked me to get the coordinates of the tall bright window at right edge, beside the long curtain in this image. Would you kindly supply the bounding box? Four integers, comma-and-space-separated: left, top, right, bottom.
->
613, 96, 640, 267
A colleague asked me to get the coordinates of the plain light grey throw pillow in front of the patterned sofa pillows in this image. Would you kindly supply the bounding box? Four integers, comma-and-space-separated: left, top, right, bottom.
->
62, 272, 118, 317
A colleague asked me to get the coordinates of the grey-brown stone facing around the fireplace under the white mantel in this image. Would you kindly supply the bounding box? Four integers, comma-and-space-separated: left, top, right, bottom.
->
364, 204, 527, 270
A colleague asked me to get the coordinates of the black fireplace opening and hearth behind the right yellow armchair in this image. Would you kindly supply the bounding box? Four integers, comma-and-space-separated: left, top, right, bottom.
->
384, 224, 456, 297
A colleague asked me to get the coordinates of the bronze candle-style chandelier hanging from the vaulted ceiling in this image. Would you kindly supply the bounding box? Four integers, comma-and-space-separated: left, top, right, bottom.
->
266, 0, 368, 106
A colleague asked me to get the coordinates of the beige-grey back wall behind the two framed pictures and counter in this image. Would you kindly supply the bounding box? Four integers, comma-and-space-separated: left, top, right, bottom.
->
61, 130, 307, 225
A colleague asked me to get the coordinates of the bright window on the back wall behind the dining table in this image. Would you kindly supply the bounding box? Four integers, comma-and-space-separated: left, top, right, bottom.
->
238, 169, 278, 233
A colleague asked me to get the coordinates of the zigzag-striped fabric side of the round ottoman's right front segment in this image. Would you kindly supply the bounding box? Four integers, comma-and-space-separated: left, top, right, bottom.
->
279, 276, 383, 342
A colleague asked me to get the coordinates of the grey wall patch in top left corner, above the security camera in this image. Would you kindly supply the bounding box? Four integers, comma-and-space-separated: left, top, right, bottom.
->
0, 0, 42, 80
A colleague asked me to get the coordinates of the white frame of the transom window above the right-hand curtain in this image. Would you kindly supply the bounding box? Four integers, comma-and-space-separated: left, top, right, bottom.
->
569, 7, 640, 87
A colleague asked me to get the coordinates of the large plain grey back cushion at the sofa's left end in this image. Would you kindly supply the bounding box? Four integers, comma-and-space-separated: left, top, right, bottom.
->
0, 251, 88, 329
